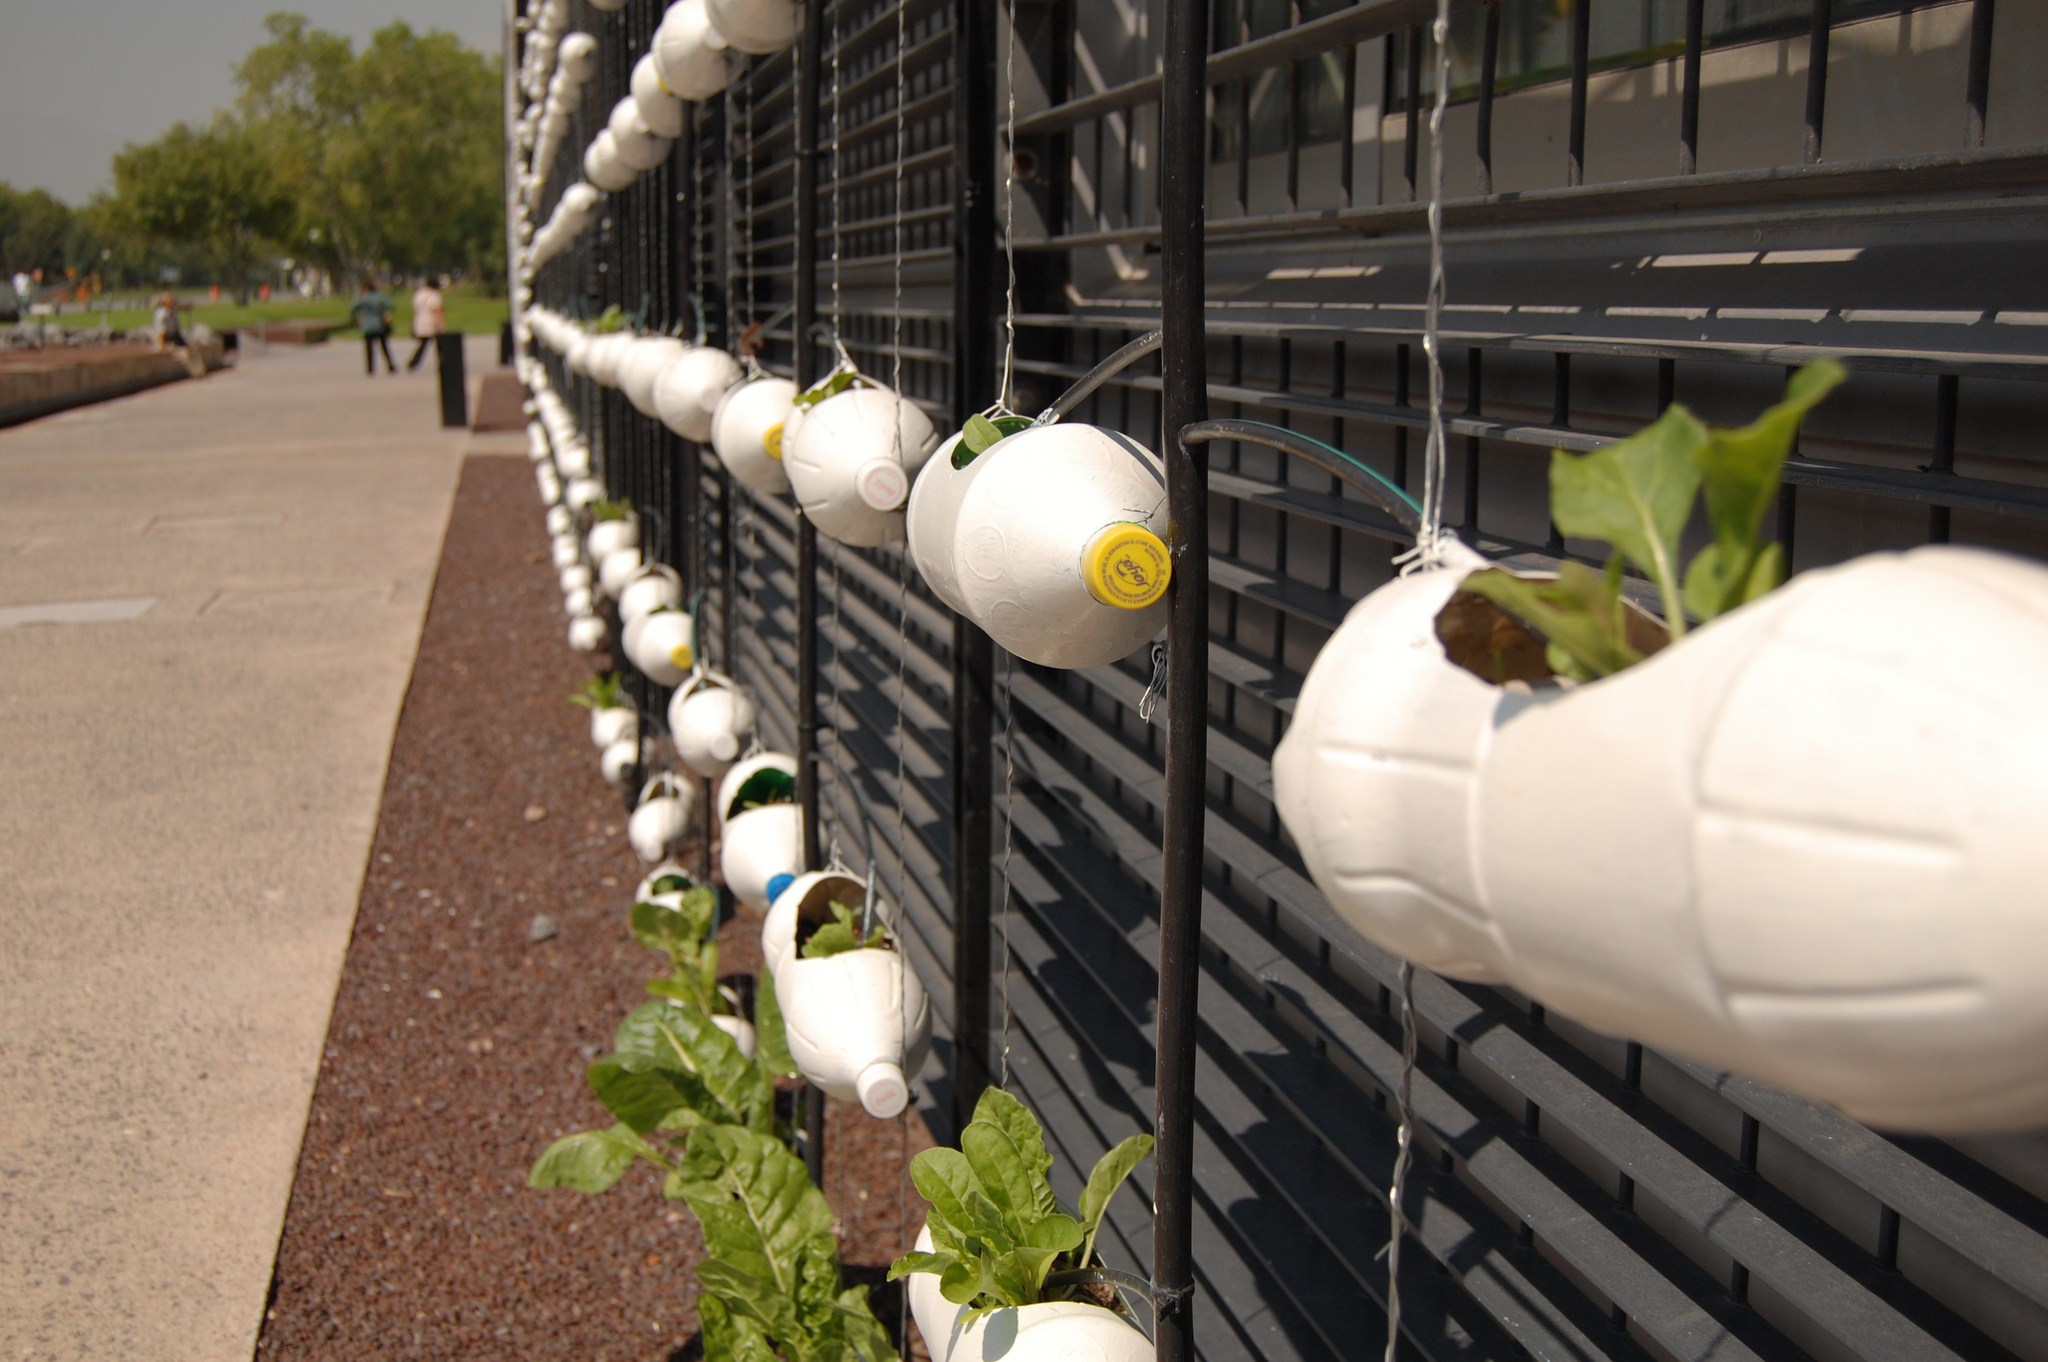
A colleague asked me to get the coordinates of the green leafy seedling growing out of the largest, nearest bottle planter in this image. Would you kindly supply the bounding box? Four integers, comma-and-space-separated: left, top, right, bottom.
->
1446, 360, 1847, 680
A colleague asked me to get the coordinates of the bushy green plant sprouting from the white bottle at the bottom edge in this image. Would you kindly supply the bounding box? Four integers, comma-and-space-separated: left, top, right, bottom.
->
889, 1088, 1153, 1323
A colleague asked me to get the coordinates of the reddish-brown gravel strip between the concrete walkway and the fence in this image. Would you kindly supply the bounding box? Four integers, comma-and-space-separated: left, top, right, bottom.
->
256, 457, 930, 1362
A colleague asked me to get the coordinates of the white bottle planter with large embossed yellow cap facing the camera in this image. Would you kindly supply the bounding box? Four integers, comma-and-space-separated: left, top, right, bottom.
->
905, 424, 1171, 668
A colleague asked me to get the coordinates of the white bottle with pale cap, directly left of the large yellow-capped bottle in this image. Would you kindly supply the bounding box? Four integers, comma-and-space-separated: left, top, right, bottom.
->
782, 387, 938, 549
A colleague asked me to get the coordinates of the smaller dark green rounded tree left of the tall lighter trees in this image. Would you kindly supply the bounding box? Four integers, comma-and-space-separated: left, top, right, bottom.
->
104, 115, 293, 303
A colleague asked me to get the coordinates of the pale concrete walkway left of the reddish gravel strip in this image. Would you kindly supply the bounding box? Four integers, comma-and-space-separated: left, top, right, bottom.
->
0, 338, 491, 1362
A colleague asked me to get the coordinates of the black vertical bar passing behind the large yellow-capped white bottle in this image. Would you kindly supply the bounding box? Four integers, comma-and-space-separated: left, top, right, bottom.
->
950, 0, 1003, 1129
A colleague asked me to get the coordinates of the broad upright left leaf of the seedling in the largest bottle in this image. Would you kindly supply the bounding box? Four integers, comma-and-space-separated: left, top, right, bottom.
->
1548, 403, 1708, 637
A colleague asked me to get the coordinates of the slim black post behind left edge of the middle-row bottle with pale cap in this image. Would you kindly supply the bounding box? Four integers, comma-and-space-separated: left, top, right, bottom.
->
795, 0, 825, 1182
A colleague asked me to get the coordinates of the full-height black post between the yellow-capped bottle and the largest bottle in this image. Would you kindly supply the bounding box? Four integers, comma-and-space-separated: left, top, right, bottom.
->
1153, 0, 1208, 1362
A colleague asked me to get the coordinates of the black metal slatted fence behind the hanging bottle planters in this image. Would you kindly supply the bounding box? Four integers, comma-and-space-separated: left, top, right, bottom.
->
539, 0, 2048, 1362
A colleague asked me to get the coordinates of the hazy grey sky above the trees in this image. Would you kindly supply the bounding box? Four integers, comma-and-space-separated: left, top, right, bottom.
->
0, 0, 504, 205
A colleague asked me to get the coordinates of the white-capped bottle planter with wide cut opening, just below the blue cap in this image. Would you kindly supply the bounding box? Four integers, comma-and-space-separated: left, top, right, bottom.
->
762, 870, 932, 1120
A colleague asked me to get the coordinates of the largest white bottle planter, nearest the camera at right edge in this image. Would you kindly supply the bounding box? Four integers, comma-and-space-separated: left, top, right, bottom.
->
1274, 547, 2048, 1133
